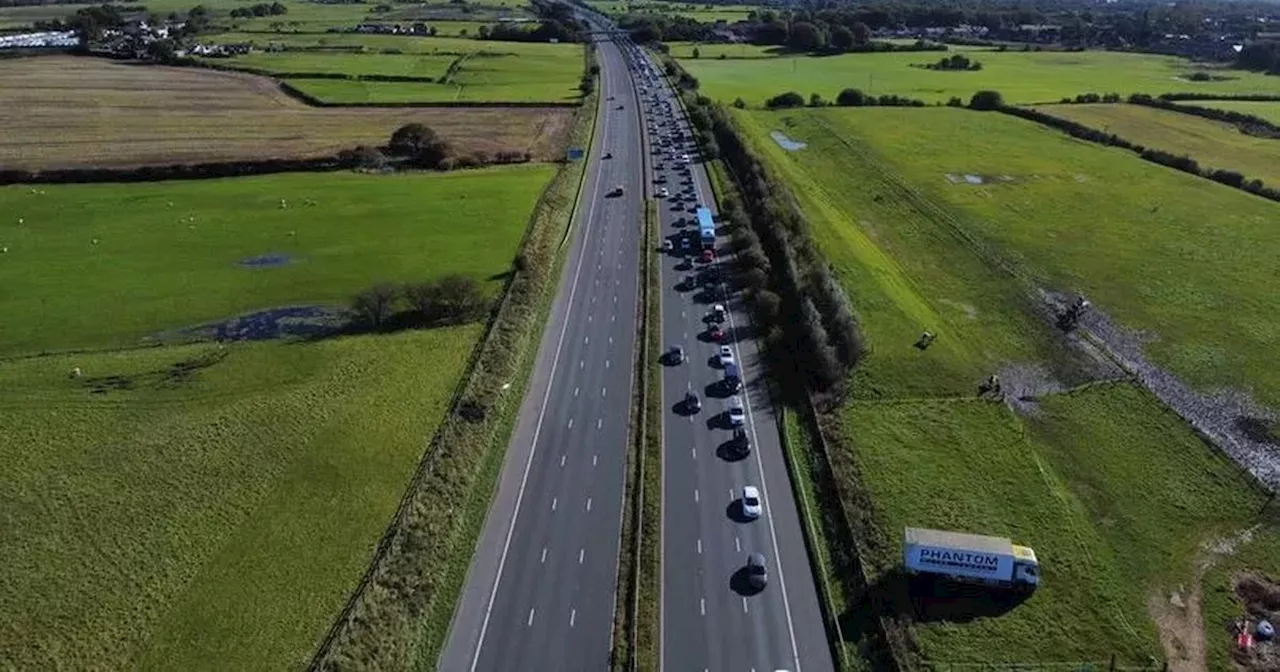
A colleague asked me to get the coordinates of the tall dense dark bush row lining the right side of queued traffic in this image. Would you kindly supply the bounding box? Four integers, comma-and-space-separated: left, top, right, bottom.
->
666, 58, 864, 401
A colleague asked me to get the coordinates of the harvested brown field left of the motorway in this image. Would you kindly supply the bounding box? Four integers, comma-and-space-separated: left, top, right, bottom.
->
0, 56, 573, 170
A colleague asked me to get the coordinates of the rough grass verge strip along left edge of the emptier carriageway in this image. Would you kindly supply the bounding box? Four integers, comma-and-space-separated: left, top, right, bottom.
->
314, 80, 598, 669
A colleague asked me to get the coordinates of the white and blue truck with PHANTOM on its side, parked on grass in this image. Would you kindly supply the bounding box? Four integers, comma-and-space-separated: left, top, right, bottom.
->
902, 527, 1039, 590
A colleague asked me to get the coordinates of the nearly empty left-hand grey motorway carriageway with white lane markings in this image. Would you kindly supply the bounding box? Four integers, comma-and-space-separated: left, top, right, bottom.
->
438, 32, 644, 672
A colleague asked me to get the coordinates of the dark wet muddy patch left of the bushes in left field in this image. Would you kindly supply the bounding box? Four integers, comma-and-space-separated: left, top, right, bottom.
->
152, 306, 349, 340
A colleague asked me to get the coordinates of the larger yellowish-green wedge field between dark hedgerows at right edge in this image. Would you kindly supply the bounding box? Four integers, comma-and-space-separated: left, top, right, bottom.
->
1041, 104, 1280, 184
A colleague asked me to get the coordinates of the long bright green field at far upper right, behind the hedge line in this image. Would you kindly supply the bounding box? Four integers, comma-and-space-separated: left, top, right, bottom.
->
677, 45, 1280, 106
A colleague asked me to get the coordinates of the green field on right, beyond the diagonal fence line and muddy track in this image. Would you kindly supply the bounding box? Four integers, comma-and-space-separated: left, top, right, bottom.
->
740, 109, 1280, 404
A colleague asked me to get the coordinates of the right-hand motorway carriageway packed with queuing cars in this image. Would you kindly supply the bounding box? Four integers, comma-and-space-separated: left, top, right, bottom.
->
637, 45, 833, 672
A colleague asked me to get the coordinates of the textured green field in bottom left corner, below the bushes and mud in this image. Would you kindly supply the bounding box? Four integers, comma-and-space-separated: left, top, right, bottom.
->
0, 323, 481, 669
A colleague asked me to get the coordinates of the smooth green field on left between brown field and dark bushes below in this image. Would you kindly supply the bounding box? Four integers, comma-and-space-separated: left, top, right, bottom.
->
0, 165, 554, 355
